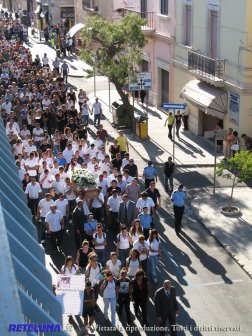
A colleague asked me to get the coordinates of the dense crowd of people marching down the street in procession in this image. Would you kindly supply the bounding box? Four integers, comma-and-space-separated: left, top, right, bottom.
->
0, 12, 178, 335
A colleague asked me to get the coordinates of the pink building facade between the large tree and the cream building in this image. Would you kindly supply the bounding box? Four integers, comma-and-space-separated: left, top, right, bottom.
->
122, 0, 176, 107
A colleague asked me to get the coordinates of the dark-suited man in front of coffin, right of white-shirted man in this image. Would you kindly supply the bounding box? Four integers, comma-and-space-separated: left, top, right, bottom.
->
72, 199, 86, 249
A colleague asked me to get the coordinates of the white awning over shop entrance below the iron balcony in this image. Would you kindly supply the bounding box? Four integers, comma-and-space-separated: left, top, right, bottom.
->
180, 79, 227, 119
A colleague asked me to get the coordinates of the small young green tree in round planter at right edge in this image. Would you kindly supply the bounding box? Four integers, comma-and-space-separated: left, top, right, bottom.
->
216, 151, 252, 212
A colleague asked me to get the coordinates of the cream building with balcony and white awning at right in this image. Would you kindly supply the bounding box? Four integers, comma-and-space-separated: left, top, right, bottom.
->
173, 0, 252, 137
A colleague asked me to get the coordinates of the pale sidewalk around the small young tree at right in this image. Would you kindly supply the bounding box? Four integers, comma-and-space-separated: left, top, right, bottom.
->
192, 188, 252, 278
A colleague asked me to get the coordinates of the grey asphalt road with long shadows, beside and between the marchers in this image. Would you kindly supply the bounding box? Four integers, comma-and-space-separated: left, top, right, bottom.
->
25, 38, 252, 336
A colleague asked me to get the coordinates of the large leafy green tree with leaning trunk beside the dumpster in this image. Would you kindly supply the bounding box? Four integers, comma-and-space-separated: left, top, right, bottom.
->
81, 13, 147, 129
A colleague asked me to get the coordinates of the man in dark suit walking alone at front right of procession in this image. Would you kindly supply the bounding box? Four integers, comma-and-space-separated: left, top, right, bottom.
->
154, 280, 178, 336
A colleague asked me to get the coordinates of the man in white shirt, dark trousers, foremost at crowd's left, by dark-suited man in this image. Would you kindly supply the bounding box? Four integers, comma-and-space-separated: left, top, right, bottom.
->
45, 205, 64, 252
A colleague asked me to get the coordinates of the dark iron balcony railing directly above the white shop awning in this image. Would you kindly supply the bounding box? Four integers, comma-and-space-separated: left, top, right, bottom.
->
188, 50, 225, 80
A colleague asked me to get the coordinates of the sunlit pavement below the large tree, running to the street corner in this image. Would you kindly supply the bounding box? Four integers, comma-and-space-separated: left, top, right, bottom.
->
89, 90, 222, 168
